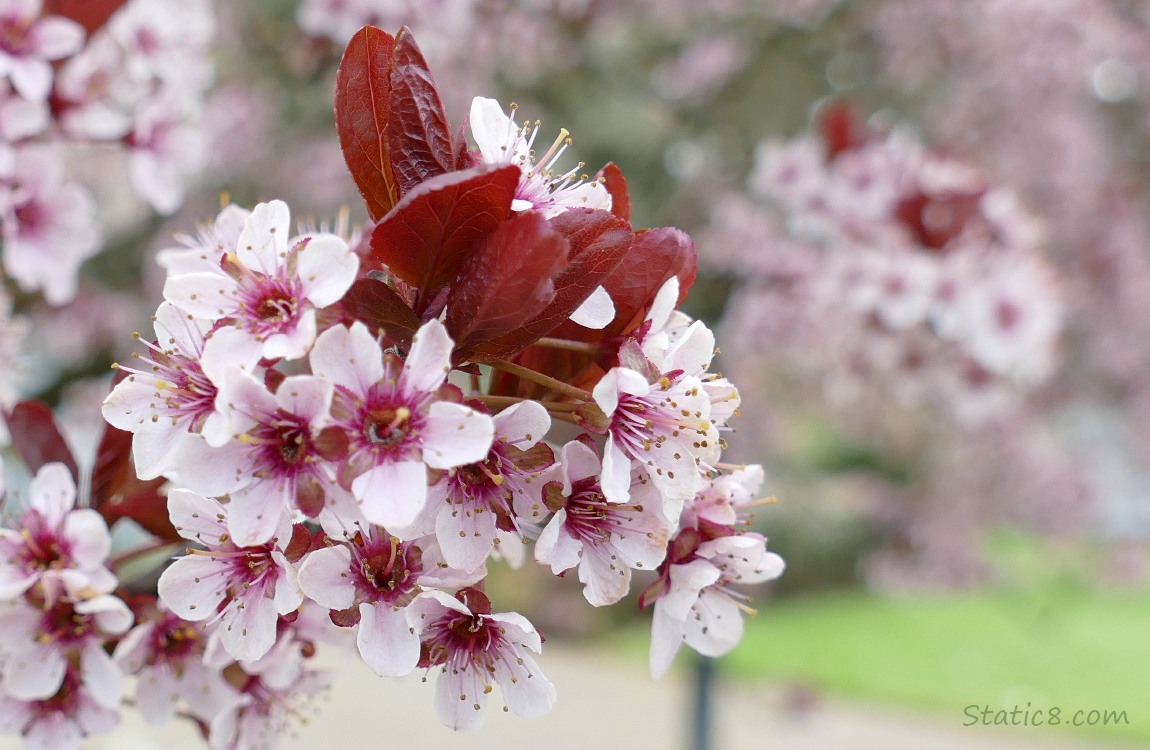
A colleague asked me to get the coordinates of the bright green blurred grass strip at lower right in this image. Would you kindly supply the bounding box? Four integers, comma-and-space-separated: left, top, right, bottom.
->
725, 587, 1150, 743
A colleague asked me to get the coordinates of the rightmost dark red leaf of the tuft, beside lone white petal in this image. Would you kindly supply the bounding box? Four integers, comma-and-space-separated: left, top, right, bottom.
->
603, 227, 698, 336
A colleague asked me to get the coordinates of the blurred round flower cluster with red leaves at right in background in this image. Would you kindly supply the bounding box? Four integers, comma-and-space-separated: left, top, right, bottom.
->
703, 106, 1061, 421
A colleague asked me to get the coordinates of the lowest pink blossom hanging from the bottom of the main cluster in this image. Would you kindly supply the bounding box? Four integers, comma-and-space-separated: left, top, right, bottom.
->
408, 589, 555, 732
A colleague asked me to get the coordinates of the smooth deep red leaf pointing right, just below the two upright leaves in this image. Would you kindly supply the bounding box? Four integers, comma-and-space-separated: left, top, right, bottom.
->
368, 164, 521, 314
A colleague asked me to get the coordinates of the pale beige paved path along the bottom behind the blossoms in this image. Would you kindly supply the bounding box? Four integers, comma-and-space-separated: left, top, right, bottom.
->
8, 643, 1128, 750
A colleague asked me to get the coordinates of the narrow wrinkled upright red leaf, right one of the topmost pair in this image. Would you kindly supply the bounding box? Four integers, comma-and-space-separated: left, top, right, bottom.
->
388, 26, 455, 197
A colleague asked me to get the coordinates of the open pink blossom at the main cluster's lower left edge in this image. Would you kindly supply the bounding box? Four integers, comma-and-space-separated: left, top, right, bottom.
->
158, 490, 302, 660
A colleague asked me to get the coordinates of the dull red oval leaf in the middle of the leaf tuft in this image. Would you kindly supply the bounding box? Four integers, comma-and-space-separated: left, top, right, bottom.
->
445, 212, 569, 351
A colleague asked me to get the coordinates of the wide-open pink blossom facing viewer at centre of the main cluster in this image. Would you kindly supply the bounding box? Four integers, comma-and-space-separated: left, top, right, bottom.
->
311, 320, 495, 528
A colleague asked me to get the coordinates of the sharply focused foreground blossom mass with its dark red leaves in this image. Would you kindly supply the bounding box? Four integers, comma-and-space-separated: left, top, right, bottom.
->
0, 26, 783, 748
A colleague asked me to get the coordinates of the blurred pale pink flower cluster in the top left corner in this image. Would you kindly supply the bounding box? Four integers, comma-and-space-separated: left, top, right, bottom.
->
0, 0, 213, 305
